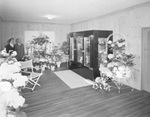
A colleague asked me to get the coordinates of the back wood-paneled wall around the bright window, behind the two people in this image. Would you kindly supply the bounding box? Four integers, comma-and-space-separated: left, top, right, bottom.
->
2, 21, 70, 47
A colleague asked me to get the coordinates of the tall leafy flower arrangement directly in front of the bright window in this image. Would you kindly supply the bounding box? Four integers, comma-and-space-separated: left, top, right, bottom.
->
24, 35, 49, 69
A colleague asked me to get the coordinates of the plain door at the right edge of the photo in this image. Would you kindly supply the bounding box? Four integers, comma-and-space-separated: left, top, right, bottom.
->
141, 27, 150, 92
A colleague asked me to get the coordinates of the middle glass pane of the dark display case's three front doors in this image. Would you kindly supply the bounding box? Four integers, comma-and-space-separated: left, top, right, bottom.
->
77, 36, 83, 63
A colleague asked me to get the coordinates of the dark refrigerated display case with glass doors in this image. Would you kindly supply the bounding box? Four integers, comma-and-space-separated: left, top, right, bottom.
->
68, 30, 113, 69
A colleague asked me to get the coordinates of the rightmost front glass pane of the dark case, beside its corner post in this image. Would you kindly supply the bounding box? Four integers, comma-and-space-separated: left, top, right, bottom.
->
84, 37, 90, 67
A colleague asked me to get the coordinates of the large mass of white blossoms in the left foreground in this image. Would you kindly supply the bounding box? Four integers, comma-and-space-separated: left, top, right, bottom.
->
0, 57, 28, 117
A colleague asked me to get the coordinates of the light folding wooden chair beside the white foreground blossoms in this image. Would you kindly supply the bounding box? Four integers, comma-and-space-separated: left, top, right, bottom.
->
20, 59, 43, 91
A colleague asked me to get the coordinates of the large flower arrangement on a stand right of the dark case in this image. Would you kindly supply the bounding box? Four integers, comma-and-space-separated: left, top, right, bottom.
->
99, 35, 135, 92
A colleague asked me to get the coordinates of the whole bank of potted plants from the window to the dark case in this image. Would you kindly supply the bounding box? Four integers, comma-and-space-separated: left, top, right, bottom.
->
26, 35, 66, 69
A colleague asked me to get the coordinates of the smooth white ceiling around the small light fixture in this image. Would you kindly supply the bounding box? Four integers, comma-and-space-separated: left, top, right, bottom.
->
0, 0, 150, 24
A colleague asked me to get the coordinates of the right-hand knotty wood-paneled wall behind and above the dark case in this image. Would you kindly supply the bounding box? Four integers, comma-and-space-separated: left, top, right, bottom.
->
71, 3, 150, 89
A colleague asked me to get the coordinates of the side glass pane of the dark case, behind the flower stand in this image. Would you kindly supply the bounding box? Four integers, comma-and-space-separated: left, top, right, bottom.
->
98, 38, 107, 67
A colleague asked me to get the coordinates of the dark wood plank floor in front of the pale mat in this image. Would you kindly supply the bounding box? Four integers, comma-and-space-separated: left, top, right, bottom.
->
23, 70, 150, 117
